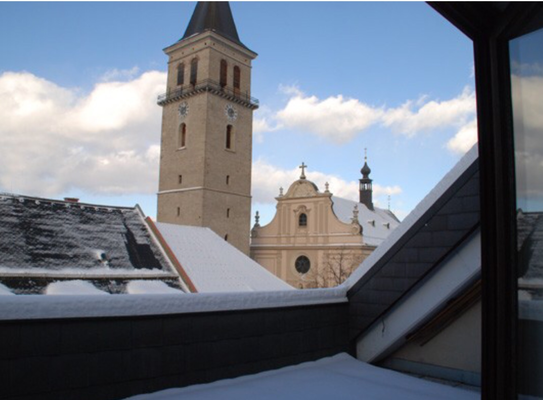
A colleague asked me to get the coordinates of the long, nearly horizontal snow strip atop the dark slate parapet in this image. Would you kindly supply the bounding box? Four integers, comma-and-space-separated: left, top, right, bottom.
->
0, 287, 348, 321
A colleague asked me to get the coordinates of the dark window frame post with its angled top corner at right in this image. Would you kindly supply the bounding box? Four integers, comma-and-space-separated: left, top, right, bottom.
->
429, 2, 543, 400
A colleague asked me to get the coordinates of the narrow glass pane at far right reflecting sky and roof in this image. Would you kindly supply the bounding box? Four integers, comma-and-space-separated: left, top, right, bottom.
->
510, 29, 543, 399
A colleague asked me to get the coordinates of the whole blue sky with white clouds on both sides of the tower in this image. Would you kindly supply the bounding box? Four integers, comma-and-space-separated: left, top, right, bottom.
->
0, 2, 475, 223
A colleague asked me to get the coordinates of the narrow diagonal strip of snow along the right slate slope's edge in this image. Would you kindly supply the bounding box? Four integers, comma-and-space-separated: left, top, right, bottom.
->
341, 143, 479, 290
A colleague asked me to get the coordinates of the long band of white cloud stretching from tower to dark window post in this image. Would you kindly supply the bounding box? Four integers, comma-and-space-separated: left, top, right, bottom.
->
262, 86, 476, 144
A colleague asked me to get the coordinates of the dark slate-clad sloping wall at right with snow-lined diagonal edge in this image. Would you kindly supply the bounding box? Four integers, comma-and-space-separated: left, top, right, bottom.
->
348, 149, 480, 338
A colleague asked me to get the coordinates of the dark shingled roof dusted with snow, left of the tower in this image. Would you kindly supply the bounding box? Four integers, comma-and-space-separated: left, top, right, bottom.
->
0, 194, 184, 293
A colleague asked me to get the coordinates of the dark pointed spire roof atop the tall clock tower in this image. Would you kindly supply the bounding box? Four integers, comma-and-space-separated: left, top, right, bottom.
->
181, 1, 246, 47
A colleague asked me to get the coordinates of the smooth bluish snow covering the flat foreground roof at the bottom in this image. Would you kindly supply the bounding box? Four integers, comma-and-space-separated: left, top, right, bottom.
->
127, 353, 481, 400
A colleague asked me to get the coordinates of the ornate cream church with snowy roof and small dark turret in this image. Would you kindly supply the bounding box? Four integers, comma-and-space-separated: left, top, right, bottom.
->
251, 162, 399, 289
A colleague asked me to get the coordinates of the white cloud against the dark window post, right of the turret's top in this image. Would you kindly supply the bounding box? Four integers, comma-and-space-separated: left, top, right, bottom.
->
382, 88, 476, 137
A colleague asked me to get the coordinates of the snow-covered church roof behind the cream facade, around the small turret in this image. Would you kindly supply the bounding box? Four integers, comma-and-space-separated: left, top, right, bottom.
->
332, 196, 400, 246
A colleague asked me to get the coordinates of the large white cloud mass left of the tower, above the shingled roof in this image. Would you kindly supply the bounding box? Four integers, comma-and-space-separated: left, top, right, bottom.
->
0, 71, 166, 196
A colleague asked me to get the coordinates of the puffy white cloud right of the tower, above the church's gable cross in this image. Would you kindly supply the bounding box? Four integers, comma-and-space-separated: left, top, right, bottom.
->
276, 87, 383, 144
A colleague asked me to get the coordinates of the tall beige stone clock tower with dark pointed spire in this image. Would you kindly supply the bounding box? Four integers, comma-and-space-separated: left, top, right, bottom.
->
157, 2, 258, 254
